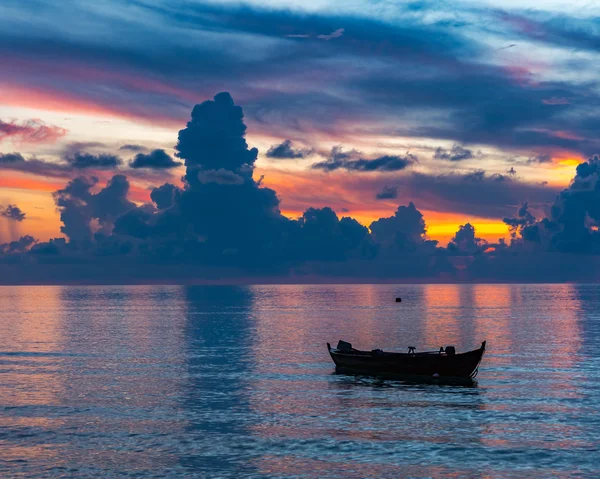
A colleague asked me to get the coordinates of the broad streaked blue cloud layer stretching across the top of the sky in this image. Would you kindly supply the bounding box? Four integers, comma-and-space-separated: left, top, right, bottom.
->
0, 2, 600, 158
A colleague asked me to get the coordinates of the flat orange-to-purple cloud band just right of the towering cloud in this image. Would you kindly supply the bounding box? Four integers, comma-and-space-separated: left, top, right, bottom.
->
267, 164, 562, 220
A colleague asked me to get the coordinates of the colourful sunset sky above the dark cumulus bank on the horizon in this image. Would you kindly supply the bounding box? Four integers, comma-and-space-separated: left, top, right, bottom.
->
0, 0, 600, 282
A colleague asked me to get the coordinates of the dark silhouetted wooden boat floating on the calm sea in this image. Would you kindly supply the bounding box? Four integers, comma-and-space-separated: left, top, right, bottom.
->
327, 341, 486, 379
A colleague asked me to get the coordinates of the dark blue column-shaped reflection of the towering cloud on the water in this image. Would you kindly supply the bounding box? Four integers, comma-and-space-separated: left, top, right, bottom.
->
180, 286, 260, 475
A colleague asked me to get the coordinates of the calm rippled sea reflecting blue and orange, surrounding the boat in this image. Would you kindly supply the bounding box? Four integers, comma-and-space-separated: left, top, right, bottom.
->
0, 285, 600, 478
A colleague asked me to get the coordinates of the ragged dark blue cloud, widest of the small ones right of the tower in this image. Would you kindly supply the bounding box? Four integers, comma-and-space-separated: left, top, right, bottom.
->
311, 146, 419, 172
